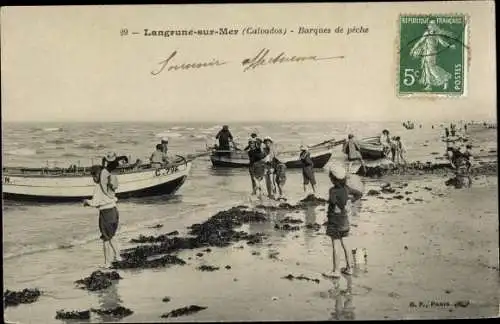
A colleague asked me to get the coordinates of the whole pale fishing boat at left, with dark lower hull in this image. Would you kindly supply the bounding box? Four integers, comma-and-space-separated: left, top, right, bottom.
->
2, 156, 192, 202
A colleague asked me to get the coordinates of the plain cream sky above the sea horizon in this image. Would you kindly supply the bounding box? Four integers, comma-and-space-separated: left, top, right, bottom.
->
1, 2, 496, 122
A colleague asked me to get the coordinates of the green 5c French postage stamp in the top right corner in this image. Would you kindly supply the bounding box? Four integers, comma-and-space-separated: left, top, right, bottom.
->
398, 14, 469, 96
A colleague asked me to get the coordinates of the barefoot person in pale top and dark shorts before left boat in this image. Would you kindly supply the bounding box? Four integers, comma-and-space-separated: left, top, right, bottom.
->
83, 153, 119, 264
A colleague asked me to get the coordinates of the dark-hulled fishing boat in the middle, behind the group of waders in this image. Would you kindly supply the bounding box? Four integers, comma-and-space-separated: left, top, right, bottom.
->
209, 139, 345, 169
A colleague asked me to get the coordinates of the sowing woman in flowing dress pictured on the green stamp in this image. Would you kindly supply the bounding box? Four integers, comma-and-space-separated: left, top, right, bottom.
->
410, 20, 455, 90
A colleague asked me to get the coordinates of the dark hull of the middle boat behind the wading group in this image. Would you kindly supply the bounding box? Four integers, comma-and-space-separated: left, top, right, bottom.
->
210, 152, 332, 169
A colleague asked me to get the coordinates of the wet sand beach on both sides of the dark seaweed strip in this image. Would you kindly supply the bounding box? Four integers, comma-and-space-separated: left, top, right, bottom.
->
4, 123, 500, 323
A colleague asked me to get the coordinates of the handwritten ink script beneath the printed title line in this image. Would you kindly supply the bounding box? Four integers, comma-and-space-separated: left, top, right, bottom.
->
151, 48, 344, 76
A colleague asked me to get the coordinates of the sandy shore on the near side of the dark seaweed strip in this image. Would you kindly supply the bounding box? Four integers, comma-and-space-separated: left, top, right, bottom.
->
6, 172, 500, 323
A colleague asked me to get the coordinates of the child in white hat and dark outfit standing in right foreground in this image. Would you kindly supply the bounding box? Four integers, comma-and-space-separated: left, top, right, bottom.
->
325, 165, 361, 278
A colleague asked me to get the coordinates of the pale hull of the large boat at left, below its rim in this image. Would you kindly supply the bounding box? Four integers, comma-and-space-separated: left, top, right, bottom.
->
3, 162, 191, 202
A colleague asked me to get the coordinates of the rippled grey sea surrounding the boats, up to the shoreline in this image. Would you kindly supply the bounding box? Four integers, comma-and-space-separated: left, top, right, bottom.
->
2, 122, 496, 289
